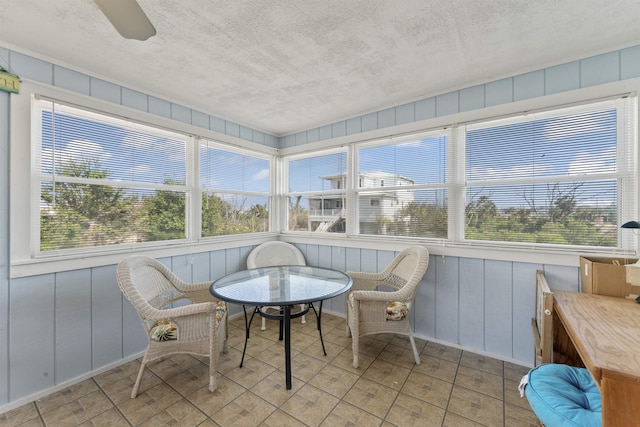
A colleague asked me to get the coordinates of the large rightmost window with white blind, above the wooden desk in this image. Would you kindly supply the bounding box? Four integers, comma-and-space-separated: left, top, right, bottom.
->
464, 99, 635, 248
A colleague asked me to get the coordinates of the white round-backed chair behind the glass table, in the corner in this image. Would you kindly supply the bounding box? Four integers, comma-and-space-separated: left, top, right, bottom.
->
247, 241, 307, 331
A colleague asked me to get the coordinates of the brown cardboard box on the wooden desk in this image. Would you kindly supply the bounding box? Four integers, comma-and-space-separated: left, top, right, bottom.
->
580, 257, 640, 298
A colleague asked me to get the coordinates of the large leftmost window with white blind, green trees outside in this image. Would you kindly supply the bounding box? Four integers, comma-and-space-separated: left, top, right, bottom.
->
33, 99, 187, 252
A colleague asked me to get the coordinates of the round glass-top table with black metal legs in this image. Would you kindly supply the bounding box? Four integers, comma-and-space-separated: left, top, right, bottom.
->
209, 266, 352, 390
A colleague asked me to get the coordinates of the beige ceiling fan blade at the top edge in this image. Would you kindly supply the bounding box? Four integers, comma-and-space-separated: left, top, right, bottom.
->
93, 0, 156, 40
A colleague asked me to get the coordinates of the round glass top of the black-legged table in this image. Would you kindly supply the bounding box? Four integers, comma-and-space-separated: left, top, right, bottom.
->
209, 266, 352, 305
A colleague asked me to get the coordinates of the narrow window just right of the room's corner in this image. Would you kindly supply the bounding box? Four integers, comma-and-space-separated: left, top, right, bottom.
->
286, 150, 347, 233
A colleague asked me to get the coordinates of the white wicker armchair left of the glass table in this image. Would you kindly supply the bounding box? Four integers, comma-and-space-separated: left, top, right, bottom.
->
116, 256, 228, 398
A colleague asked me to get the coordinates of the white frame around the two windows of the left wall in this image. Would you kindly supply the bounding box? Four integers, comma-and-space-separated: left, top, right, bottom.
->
9, 80, 277, 277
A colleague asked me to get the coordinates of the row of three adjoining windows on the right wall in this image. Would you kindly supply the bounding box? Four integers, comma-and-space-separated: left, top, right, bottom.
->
286, 97, 637, 251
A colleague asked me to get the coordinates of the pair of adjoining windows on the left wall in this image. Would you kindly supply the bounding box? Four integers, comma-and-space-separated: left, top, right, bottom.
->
32, 99, 271, 254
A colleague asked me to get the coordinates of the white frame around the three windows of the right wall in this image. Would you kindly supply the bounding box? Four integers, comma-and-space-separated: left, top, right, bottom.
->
282, 95, 640, 256
